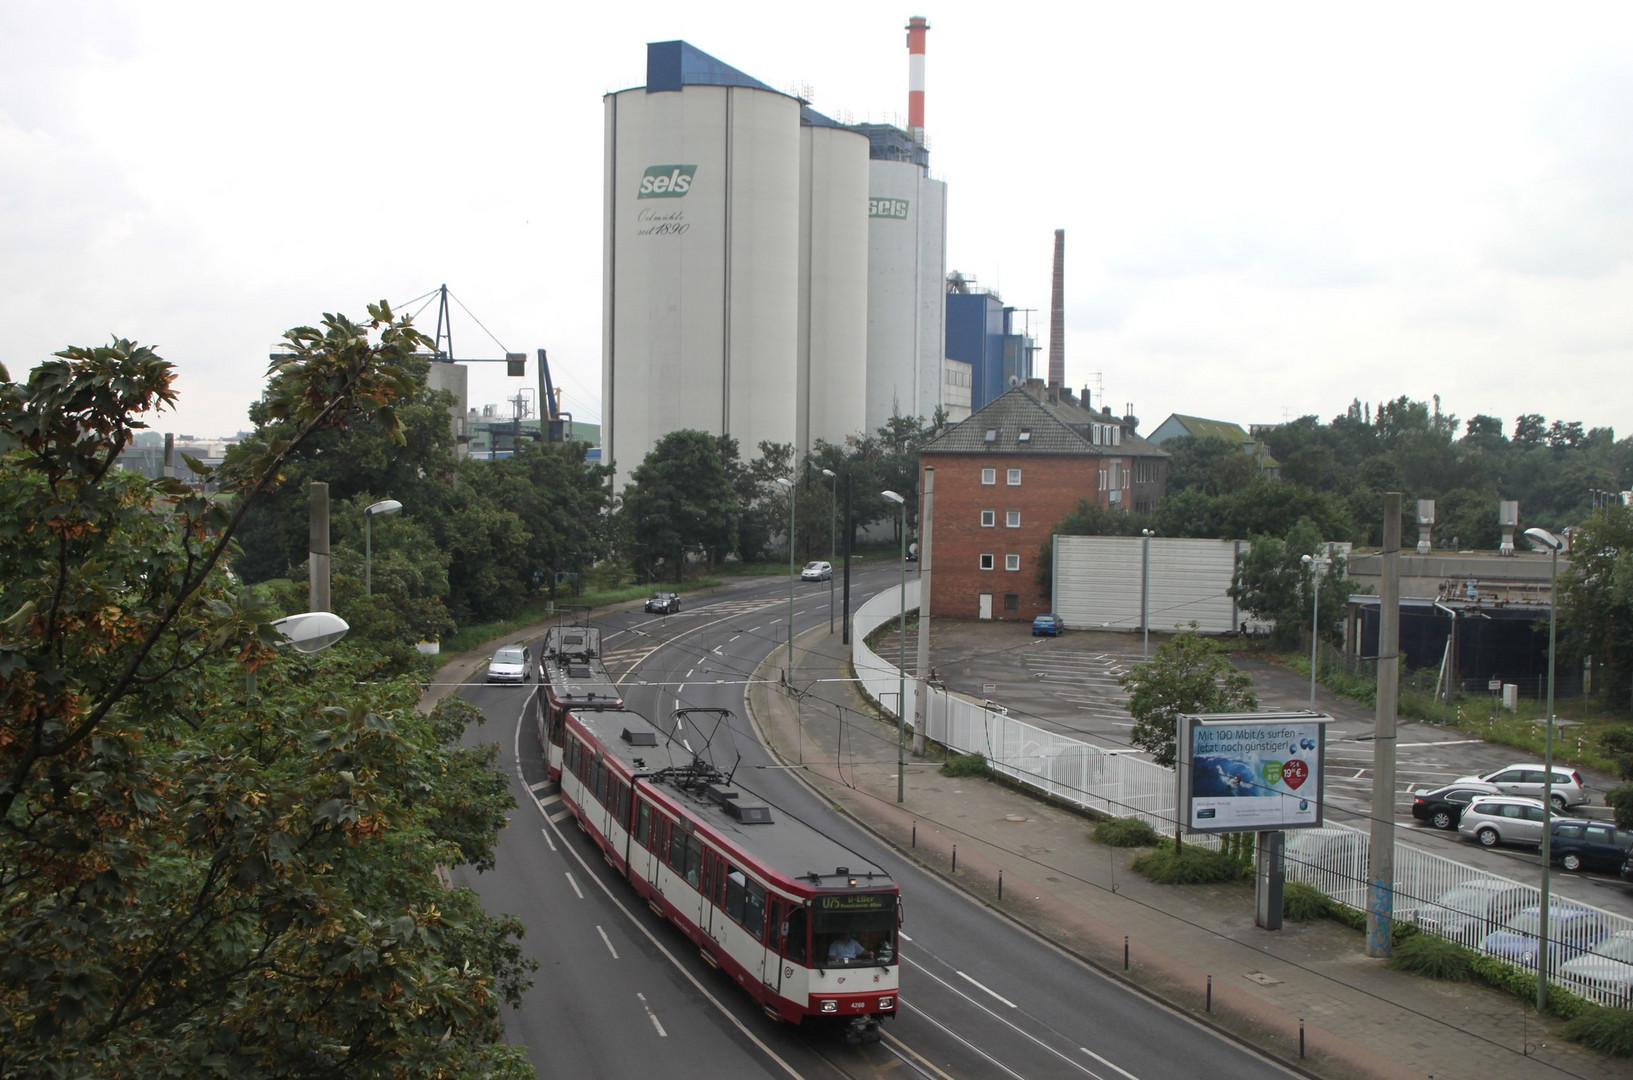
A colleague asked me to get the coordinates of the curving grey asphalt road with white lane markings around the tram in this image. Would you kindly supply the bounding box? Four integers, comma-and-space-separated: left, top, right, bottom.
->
456, 564, 1290, 1080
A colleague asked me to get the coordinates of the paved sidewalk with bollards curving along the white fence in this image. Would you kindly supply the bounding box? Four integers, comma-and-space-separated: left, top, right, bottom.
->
748, 617, 1628, 1080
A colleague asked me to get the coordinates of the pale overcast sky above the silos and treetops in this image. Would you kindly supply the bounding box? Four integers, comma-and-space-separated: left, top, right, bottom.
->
0, 0, 1633, 438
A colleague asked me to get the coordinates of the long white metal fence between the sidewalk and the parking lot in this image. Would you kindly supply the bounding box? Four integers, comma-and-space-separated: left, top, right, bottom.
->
851, 582, 1633, 1008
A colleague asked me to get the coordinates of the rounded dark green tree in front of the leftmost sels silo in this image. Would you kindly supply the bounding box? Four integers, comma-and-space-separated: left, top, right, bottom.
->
619, 428, 740, 582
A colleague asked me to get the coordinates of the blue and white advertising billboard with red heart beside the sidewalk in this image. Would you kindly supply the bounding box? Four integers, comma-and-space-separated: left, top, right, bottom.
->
1177, 712, 1333, 833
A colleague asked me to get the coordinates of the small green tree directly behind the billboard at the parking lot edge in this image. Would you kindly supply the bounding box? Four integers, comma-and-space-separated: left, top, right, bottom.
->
1117, 623, 1259, 768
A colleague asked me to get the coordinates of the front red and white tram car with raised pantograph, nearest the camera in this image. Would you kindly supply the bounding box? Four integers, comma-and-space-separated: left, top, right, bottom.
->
560, 709, 901, 1042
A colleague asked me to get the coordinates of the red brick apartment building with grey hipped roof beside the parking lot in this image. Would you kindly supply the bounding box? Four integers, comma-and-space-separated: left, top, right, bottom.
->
919, 379, 1168, 621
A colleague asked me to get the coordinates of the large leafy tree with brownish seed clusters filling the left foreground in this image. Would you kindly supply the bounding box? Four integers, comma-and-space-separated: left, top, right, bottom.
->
0, 304, 526, 1078
